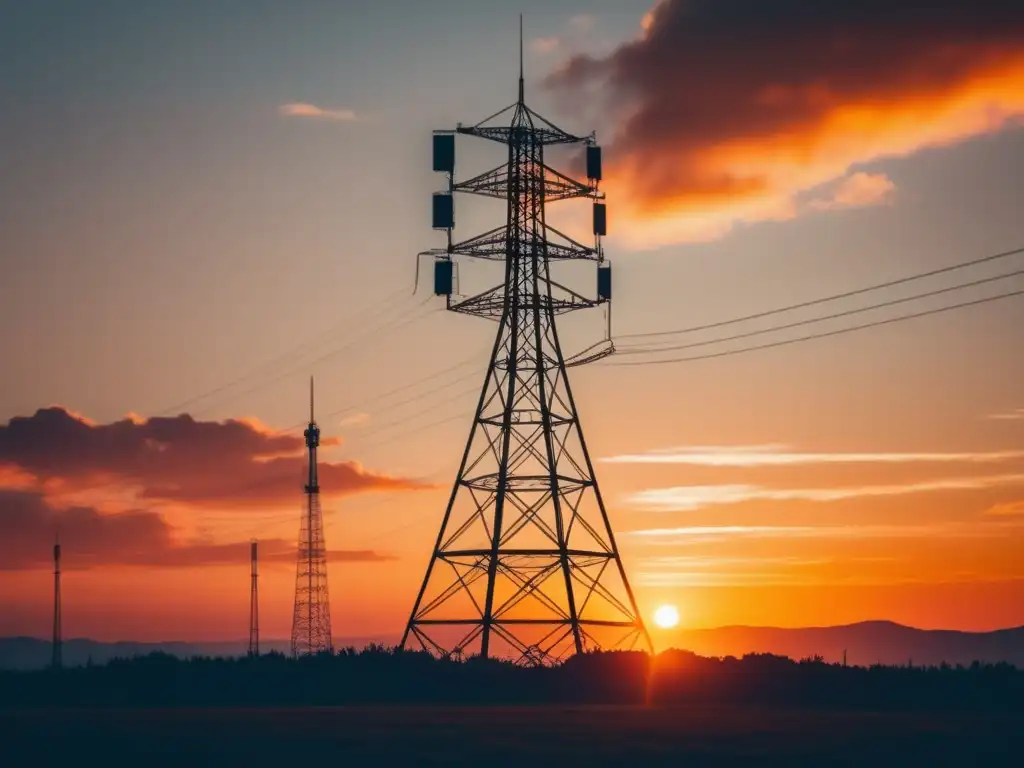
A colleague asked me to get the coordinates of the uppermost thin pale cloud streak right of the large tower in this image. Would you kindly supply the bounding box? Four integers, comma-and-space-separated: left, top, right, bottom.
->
601, 444, 1024, 467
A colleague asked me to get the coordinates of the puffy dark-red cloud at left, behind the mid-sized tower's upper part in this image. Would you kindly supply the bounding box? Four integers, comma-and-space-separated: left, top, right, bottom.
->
0, 408, 426, 509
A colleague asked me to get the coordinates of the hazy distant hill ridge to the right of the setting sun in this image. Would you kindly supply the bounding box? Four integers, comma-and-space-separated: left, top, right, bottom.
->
670, 622, 1024, 669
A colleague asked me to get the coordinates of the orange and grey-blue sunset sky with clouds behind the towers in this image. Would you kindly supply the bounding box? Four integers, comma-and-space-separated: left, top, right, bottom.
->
0, 0, 1024, 645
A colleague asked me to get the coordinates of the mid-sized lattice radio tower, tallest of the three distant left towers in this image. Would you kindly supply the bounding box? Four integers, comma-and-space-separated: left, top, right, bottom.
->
292, 377, 333, 656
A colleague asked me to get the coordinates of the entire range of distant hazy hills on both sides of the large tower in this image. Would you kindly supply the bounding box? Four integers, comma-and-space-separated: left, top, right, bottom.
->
0, 622, 1024, 670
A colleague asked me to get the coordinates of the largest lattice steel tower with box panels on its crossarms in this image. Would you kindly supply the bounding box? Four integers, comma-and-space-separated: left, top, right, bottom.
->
401, 16, 651, 666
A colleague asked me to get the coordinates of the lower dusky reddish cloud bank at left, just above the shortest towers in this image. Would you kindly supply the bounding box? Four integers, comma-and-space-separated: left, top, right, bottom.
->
0, 490, 394, 570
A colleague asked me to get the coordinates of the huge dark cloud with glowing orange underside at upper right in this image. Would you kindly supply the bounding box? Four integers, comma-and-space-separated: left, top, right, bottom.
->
546, 0, 1024, 248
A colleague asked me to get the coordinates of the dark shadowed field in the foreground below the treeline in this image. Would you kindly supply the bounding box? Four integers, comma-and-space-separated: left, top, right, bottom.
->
8, 707, 1024, 768
